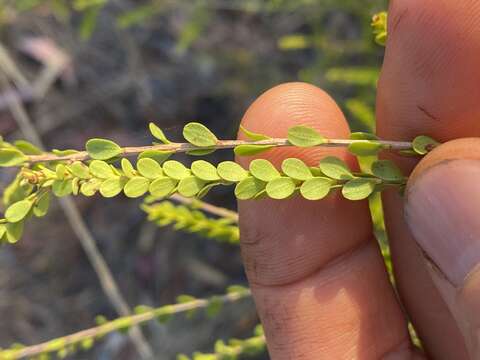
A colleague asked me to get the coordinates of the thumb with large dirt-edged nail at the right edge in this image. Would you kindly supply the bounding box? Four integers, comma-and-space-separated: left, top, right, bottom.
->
405, 138, 480, 359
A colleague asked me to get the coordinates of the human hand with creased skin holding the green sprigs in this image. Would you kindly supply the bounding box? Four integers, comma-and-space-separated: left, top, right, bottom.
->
239, 0, 480, 360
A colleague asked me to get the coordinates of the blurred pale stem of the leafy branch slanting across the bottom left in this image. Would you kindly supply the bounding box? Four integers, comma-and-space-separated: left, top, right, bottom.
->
0, 290, 250, 359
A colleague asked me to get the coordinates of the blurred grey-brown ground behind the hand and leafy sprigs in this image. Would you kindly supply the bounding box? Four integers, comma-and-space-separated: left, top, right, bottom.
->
0, 0, 387, 359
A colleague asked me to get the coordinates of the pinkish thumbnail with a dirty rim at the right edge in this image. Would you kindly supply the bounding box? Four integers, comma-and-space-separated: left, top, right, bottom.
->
405, 160, 480, 287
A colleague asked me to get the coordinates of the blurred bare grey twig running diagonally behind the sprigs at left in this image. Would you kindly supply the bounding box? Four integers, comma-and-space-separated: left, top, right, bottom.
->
0, 59, 154, 359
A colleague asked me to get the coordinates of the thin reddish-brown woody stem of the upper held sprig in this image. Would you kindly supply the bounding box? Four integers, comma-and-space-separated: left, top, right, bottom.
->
27, 139, 412, 164
